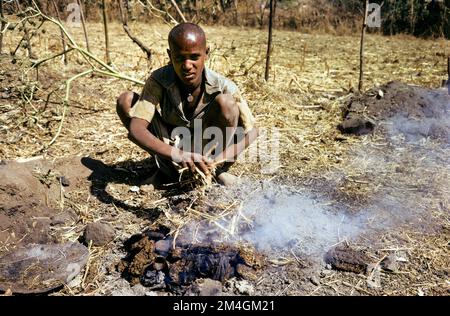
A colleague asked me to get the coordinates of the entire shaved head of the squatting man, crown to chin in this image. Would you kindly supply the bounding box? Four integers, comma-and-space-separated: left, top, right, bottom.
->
167, 23, 209, 88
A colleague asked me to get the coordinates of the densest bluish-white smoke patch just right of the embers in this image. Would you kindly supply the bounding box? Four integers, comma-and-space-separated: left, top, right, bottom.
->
242, 185, 365, 255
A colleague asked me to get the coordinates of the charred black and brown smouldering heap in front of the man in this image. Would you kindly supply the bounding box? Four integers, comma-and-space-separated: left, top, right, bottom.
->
118, 229, 262, 294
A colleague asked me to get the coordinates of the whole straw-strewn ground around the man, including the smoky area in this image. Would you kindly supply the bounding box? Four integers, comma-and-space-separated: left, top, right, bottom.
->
0, 24, 450, 295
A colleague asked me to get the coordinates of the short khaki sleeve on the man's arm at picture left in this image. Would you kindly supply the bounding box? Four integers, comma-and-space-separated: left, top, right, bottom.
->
129, 76, 162, 123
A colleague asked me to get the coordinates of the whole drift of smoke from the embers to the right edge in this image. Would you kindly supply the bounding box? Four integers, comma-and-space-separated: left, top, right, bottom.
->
178, 89, 450, 259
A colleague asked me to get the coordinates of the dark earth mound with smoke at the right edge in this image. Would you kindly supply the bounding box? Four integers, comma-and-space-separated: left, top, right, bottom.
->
338, 81, 450, 142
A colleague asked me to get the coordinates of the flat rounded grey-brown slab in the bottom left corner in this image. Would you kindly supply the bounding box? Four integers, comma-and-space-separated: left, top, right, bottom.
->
0, 242, 89, 294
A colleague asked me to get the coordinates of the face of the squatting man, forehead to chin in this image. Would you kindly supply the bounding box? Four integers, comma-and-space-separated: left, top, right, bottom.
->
167, 33, 209, 87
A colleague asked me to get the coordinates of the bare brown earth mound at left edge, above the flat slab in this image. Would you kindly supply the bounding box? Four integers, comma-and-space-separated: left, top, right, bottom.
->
0, 158, 90, 255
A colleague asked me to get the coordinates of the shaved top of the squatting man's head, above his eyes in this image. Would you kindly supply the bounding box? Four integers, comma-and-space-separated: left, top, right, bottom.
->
169, 23, 206, 49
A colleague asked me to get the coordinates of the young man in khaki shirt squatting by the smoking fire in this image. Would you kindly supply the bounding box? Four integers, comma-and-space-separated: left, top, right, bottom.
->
117, 23, 258, 185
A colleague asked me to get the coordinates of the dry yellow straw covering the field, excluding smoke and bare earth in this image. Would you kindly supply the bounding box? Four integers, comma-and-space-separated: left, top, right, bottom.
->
0, 24, 450, 295
